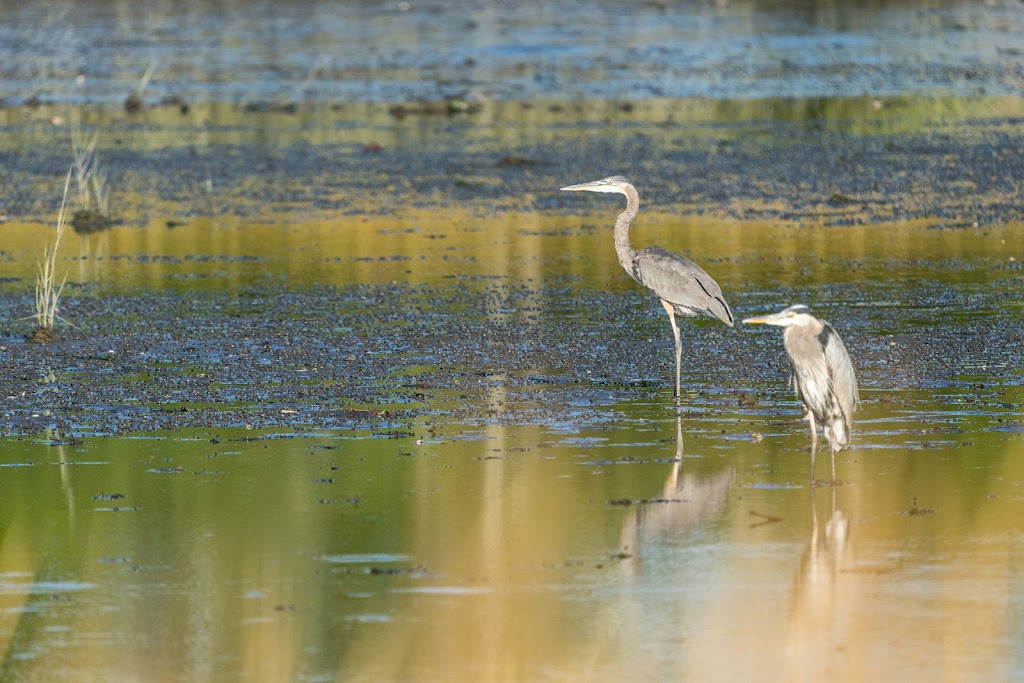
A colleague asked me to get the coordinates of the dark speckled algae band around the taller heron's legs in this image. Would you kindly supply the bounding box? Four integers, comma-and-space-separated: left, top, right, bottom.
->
0, 264, 1024, 436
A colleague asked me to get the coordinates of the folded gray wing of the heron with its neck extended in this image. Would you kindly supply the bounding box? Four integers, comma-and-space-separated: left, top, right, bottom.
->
632, 247, 733, 327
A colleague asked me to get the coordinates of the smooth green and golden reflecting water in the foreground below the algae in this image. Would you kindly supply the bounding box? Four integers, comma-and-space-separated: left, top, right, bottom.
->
0, 397, 1024, 681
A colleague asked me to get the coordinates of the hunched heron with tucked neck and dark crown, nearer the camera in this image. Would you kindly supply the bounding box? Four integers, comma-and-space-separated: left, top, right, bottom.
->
743, 304, 860, 481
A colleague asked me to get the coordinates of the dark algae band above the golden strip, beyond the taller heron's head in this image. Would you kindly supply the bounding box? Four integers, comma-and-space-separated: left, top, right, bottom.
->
6, 96, 1024, 227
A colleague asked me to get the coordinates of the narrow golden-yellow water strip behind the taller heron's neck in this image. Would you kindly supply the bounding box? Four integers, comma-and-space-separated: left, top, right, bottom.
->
4, 208, 1024, 295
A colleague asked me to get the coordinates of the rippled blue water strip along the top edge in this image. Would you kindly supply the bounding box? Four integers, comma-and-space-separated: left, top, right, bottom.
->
0, 0, 1024, 102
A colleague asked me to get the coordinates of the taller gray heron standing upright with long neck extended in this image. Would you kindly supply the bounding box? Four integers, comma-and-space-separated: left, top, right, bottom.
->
562, 175, 733, 399
